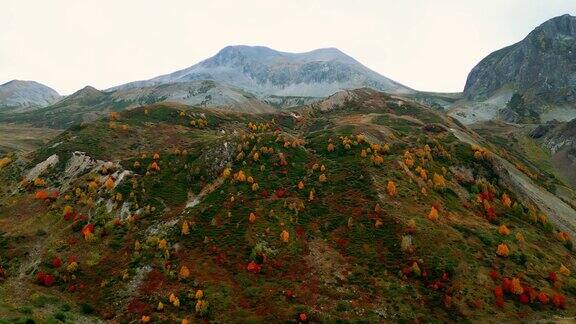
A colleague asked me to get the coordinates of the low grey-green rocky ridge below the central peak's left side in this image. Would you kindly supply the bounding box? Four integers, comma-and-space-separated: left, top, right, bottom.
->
0, 80, 275, 129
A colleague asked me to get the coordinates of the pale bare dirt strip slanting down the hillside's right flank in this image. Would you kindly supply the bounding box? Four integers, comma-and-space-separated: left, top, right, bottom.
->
450, 128, 576, 237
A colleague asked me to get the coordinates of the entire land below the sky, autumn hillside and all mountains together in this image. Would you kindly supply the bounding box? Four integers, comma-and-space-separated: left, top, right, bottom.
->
0, 9, 576, 324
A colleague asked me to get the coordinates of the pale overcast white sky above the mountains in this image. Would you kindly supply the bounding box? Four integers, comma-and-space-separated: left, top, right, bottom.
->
0, 0, 576, 94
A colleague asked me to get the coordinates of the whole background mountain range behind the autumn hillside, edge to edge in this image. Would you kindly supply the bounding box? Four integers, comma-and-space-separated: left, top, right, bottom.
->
0, 15, 576, 127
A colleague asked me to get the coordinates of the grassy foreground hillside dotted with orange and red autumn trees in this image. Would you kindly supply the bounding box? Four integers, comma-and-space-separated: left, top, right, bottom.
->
0, 89, 576, 322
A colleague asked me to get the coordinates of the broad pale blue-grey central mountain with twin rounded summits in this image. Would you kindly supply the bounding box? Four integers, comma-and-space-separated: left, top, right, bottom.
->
112, 46, 413, 97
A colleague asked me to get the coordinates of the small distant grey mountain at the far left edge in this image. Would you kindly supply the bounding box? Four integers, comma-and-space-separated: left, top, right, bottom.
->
0, 80, 60, 111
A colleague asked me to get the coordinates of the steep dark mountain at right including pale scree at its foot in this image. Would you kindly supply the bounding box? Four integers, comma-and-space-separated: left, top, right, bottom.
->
464, 15, 576, 122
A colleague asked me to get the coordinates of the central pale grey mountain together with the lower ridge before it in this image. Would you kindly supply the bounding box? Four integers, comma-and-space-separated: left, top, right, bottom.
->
0, 46, 415, 128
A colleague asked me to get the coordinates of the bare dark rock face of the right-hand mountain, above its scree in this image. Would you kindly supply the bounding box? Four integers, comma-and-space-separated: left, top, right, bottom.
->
464, 15, 576, 109
